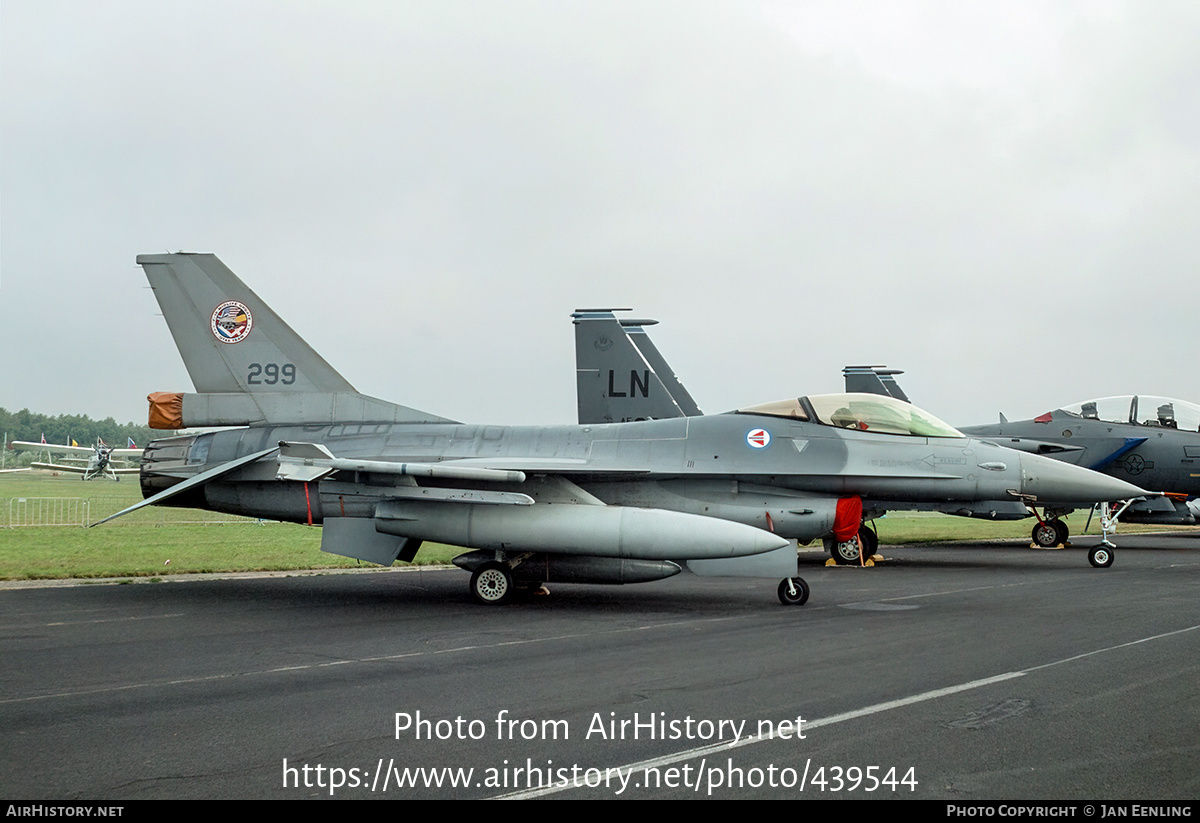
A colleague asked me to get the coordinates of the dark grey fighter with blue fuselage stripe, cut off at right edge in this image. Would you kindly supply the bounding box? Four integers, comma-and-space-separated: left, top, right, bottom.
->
842, 366, 1200, 547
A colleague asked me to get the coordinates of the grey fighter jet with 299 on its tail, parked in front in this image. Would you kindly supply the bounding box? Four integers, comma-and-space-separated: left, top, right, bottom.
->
98, 253, 1141, 603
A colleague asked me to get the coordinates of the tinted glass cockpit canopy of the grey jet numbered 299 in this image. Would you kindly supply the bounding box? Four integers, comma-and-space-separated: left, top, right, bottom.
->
737, 394, 965, 437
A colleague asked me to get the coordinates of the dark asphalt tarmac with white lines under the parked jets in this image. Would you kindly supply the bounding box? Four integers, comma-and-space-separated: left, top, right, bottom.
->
0, 530, 1200, 803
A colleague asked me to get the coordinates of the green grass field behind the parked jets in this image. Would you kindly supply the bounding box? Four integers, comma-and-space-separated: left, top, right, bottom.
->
0, 471, 1180, 579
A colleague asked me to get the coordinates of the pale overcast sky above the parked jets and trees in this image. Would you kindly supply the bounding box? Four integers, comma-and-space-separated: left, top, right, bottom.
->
0, 0, 1200, 425
